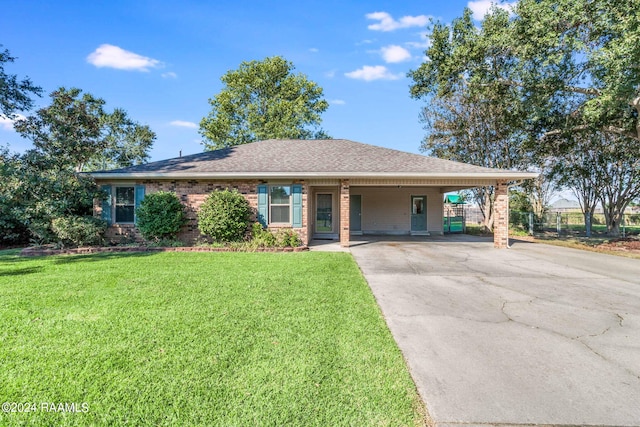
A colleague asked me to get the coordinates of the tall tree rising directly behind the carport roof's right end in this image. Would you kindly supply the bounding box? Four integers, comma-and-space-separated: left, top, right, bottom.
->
409, 9, 529, 230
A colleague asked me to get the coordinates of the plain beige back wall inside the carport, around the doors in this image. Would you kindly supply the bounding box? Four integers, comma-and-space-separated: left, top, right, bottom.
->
351, 186, 443, 234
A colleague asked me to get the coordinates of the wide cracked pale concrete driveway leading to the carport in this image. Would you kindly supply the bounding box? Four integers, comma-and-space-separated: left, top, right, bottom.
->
351, 236, 640, 427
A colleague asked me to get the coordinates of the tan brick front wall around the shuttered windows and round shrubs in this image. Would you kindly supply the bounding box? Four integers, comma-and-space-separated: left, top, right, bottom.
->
93, 180, 308, 245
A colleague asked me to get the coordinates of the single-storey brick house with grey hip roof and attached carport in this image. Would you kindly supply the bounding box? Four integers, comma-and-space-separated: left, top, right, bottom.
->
91, 140, 536, 247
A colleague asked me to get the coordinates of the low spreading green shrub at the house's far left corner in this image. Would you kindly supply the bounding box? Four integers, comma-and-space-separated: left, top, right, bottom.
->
51, 216, 107, 246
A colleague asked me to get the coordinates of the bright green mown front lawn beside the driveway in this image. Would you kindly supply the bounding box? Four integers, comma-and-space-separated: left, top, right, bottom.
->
0, 251, 424, 426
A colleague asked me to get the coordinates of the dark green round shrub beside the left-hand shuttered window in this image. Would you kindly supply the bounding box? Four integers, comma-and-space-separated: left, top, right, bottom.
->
136, 191, 187, 241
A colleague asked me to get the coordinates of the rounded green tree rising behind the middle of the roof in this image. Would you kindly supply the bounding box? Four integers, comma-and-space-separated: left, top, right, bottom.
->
200, 56, 329, 150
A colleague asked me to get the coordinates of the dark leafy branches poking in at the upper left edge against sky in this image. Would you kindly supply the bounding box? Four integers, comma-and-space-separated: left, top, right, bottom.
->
0, 45, 42, 119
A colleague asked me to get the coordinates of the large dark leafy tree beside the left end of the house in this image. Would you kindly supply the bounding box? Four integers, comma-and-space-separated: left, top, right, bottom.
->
0, 88, 155, 243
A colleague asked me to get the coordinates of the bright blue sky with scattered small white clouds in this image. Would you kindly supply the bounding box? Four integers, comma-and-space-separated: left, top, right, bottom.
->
0, 0, 510, 161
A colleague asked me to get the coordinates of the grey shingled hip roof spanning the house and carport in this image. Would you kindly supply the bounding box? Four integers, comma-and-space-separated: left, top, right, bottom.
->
90, 139, 537, 180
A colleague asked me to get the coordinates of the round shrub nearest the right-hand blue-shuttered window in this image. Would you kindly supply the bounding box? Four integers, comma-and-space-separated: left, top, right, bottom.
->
198, 190, 251, 242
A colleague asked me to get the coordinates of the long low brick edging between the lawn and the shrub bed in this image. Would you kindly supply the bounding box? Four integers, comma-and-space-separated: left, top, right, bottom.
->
20, 246, 309, 256
